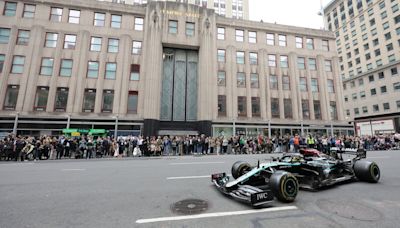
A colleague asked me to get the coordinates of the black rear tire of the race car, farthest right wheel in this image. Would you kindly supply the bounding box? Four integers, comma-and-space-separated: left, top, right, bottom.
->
354, 160, 381, 183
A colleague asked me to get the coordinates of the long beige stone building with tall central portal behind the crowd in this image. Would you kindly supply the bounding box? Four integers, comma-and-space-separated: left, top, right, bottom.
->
0, 0, 352, 136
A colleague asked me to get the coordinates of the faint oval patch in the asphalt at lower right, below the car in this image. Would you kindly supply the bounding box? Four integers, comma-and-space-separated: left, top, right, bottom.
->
317, 199, 382, 221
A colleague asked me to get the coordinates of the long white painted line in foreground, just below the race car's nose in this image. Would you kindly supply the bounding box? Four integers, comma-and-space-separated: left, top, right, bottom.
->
136, 206, 298, 223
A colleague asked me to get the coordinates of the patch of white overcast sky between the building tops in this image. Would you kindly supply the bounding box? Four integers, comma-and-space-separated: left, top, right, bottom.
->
249, 0, 331, 29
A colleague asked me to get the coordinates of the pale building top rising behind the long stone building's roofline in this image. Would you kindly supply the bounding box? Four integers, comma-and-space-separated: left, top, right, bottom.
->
99, 0, 249, 20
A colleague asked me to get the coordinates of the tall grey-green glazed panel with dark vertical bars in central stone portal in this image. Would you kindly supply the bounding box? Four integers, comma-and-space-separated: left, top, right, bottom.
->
160, 48, 198, 122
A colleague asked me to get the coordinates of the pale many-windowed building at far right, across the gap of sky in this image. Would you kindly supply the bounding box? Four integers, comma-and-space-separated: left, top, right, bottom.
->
324, 0, 400, 135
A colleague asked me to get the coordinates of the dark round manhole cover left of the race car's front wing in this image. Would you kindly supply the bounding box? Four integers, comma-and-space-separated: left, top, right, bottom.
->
171, 199, 208, 215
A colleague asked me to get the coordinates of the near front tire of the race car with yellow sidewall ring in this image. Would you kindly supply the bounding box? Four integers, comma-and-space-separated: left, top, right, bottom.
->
269, 171, 299, 203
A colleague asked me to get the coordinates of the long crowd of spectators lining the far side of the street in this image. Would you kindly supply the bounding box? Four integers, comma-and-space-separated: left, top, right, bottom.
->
0, 133, 400, 161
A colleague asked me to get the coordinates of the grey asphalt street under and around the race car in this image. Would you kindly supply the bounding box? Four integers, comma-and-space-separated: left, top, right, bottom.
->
0, 151, 400, 228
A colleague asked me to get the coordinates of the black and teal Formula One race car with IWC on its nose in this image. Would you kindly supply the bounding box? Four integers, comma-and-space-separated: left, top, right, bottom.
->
211, 148, 380, 207
